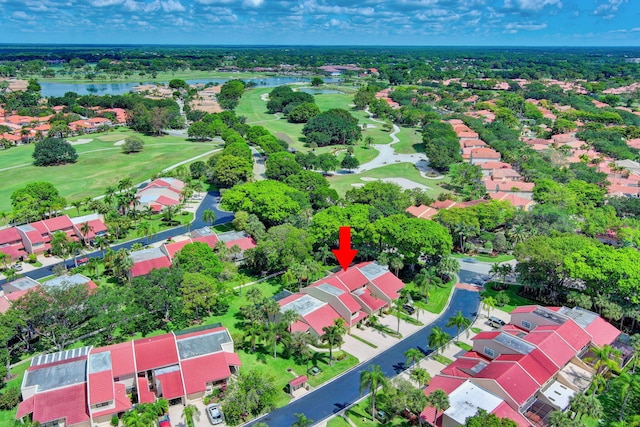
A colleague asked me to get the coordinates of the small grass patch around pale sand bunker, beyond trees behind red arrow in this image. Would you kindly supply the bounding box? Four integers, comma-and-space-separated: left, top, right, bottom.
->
328, 163, 449, 199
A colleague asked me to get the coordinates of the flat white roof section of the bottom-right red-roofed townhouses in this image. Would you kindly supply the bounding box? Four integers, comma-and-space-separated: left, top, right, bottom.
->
444, 381, 503, 424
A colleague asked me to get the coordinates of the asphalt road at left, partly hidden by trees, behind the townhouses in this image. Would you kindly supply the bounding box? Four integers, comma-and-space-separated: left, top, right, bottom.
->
0, 191, 234, 285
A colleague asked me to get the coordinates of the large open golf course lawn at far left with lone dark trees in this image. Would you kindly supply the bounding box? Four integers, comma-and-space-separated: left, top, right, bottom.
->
0, 129, 217, 211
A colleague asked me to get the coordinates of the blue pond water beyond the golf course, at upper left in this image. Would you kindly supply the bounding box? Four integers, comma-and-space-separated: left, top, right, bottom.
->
40, 76, 340, 97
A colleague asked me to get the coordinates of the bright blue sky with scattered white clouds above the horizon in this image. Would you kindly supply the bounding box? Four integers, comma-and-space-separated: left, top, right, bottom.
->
0, 0, 640, 46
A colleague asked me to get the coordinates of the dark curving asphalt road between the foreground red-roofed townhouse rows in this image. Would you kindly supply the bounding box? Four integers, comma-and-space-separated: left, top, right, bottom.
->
249, 289, 480, 427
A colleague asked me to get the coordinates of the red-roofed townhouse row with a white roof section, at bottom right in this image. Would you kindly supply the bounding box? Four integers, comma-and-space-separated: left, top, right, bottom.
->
421, 305, 626, 427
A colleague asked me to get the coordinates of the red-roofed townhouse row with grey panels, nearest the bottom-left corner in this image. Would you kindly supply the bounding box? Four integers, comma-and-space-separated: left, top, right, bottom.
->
16, 326, 241, 427
